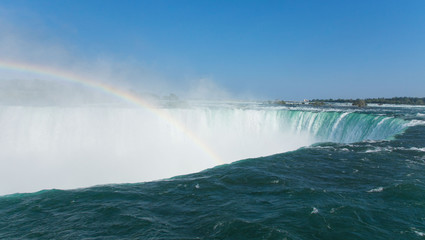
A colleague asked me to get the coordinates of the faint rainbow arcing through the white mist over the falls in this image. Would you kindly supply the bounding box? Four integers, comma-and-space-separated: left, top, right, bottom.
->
0, 60, 224, 165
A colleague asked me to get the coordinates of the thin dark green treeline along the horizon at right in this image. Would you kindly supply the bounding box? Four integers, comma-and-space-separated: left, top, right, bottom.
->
310, 97, 425, 105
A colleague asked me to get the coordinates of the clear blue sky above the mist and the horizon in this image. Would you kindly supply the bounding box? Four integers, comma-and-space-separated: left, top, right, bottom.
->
0, 0, 425, 100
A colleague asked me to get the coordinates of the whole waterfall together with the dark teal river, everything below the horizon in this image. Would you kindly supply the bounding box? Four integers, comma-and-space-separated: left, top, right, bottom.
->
0, 102, 425, 239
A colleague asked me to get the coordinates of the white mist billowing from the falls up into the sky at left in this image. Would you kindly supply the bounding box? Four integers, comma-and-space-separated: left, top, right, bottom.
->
0, 11, 311, 194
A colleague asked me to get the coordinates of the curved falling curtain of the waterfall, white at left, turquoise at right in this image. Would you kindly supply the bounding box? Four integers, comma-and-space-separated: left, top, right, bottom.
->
0, 102, 407, 194
